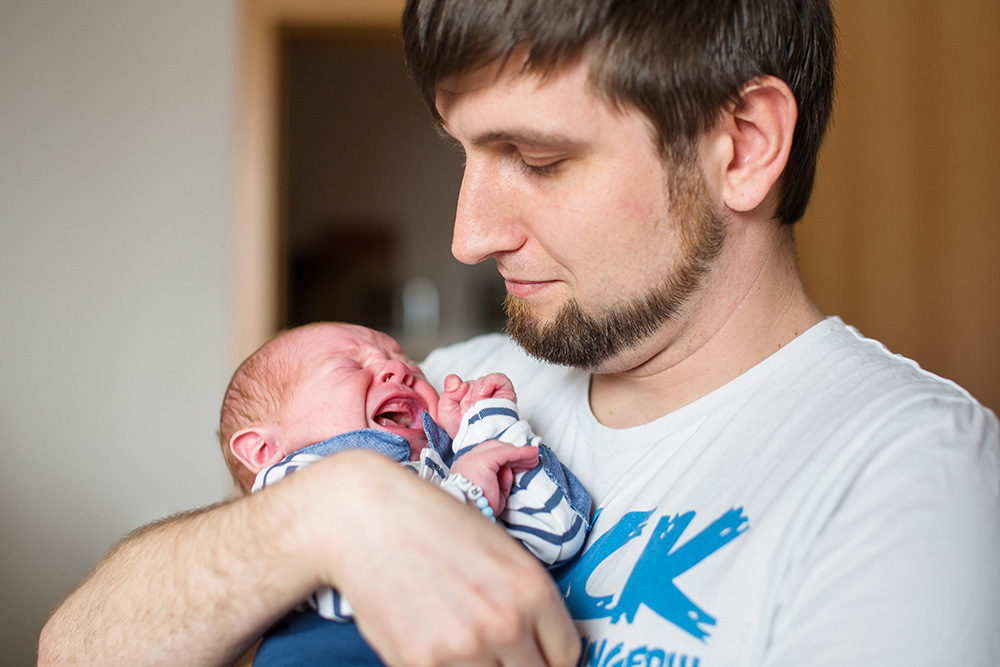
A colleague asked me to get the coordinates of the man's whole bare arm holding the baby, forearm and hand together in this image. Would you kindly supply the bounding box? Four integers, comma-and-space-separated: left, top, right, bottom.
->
39, 452, 579, 666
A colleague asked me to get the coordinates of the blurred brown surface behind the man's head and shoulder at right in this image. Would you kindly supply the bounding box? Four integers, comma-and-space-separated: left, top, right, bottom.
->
799, 0, 1000, 410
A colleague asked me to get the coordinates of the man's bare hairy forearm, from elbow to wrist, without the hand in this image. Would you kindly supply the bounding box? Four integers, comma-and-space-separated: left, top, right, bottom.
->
38, 474, 315, 666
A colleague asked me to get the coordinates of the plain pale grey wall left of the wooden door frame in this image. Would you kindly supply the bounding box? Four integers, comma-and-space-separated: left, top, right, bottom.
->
0, 0, 238, 667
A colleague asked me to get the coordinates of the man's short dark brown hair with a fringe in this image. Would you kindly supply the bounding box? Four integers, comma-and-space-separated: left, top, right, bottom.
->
402, 0, 836, 224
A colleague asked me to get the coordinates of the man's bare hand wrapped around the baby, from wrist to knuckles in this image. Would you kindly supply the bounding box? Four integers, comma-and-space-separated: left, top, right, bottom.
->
296, 452, 579, 667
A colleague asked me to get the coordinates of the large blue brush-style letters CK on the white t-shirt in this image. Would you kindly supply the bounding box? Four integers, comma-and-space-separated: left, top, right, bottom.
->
557, 507, 750, 641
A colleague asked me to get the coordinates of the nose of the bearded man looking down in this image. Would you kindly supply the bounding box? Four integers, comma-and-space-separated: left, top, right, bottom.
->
451, 159, 523, 264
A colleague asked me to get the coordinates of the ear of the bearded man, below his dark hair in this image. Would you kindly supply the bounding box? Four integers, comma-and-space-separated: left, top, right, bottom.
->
715, 76, 798, 212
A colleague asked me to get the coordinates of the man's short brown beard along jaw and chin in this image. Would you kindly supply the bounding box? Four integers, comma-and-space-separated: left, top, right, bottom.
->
504, 167, 725, 369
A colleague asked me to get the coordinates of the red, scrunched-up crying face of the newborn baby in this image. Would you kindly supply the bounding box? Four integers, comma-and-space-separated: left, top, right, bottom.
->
284, 324, 438, 459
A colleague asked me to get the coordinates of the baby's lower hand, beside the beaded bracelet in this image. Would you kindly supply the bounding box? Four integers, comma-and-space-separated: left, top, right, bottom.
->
451, 440, 538, 516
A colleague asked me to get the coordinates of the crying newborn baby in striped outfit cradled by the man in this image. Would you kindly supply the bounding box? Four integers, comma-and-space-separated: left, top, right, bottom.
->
219, 322, 590, 660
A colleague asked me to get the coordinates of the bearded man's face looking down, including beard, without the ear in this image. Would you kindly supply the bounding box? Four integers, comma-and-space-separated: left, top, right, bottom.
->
437, 58, 724, 370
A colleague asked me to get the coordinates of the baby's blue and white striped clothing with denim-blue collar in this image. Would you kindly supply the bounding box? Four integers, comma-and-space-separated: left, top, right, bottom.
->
252, 398, 590, 622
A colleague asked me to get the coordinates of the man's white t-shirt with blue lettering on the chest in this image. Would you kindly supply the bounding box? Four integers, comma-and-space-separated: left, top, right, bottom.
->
423, 318, 1000, 667
